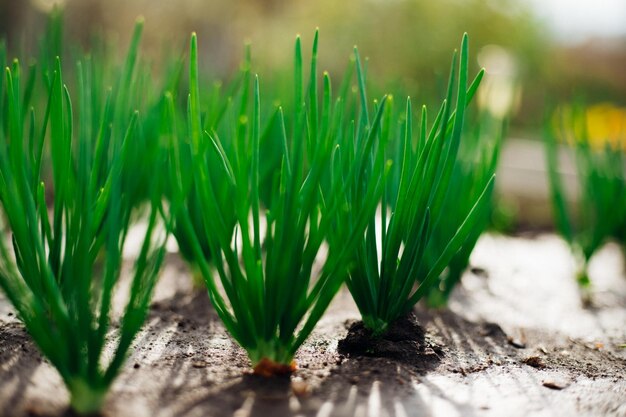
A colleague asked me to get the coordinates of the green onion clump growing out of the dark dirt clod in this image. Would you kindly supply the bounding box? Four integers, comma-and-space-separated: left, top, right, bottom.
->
345, 35, 493, 337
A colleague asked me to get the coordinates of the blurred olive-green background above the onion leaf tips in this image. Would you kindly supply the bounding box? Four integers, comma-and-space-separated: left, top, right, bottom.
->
0, 0, 626, 137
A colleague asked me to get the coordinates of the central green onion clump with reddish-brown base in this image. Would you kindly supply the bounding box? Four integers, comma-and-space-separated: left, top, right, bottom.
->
168, 34, 385, 375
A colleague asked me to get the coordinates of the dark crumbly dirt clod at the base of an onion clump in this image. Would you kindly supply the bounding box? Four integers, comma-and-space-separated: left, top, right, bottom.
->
338, 313, 441, 361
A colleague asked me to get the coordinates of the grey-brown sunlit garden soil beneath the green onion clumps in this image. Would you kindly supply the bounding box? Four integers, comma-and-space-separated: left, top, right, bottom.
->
0, 235, 626, 417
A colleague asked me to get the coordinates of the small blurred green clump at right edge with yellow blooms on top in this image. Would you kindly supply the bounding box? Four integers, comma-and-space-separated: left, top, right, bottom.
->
546, 105, 626, 302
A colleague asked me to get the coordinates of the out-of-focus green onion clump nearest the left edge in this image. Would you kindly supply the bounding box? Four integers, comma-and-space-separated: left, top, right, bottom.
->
0, 18, 166, 414
